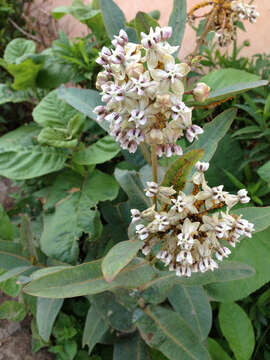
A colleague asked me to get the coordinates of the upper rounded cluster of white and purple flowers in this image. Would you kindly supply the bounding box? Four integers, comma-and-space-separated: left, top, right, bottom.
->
94, 27, 203, 157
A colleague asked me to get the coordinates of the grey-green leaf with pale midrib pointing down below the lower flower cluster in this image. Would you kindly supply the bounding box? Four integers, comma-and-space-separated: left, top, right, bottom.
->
168, 284, 212, 340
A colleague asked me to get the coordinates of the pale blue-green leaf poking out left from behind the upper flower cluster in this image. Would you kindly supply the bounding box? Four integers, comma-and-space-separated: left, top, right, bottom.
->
58, 86, 109, 132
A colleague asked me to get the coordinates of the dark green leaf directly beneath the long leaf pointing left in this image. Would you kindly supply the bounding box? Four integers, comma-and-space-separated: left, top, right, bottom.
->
92, 291, 135, 333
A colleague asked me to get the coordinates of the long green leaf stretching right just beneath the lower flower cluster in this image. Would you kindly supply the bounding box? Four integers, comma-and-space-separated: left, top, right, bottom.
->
140, 261, 254, 304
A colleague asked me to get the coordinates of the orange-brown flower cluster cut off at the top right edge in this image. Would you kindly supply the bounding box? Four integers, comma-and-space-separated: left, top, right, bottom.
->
188, 0, 259, 46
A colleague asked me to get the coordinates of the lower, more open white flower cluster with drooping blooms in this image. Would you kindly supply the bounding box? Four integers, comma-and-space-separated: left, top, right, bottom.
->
131, 162, 254, 277
